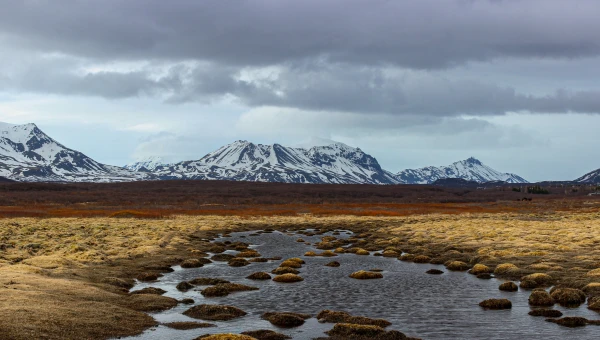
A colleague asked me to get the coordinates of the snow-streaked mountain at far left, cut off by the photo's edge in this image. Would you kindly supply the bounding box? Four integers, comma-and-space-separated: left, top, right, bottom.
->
0, 123, 148, 182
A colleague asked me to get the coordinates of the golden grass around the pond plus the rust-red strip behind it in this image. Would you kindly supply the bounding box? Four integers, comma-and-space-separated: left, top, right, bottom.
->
0, 181, 600, 339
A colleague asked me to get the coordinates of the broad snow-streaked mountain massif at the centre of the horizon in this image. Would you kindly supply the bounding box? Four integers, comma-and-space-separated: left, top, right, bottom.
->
153, 141, 398, 184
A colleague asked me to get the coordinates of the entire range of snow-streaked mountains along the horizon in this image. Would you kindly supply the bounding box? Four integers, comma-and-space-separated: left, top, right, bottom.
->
0, 123, 600, 184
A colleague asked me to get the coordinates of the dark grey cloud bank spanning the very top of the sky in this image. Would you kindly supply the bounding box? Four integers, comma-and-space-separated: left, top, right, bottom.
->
0, 0, 600, 69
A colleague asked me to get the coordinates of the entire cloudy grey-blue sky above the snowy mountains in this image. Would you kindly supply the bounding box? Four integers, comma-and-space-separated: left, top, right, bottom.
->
0, 0, 600, 181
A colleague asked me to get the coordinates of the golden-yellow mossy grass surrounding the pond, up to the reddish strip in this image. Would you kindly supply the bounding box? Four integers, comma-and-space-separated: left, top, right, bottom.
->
0, 214, 600, 339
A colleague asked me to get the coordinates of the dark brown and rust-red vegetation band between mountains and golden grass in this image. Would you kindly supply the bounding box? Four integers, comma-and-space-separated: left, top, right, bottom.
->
0, 181, 600, 218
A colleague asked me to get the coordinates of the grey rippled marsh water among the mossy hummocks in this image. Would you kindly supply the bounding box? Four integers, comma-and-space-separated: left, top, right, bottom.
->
123, 232, 600, 340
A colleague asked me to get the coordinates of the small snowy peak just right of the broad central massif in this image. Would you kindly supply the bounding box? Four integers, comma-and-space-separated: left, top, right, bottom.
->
396, 157, 527, 184
